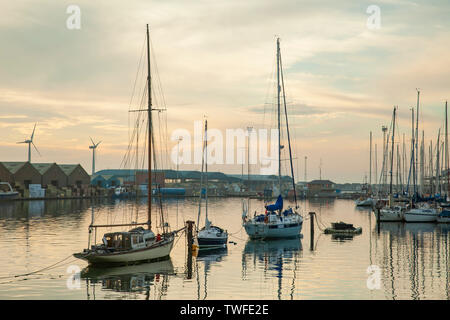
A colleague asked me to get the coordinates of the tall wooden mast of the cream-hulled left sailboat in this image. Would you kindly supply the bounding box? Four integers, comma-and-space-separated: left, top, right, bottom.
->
147, 24, 152, 230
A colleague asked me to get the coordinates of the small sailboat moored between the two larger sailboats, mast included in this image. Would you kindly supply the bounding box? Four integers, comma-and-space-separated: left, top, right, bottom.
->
197, 120, 228, 249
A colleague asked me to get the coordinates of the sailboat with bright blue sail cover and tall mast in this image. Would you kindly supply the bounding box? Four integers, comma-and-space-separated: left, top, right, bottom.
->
242, 38, 303, 239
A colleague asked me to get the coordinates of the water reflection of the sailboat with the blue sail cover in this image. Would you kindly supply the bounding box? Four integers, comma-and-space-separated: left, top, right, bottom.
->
242, 237, 303, 300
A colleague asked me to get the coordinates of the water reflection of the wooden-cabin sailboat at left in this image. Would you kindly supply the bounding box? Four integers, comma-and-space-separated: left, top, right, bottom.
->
81, 258, 175, 300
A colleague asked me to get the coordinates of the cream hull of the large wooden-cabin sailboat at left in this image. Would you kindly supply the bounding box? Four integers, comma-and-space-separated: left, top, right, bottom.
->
74, 236, 174, 265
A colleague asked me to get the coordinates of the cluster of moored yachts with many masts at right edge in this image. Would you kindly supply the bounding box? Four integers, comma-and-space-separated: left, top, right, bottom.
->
356, 90, 450, 222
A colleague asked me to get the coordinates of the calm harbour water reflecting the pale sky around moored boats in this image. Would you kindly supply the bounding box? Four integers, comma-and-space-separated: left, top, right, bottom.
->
0, 198, 450, 300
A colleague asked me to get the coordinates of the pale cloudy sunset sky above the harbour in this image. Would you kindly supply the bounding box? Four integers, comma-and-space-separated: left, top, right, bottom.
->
0, 0, 450, 182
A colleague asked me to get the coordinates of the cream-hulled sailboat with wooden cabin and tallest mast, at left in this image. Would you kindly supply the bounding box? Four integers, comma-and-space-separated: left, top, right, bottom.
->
74, 25, 178, 265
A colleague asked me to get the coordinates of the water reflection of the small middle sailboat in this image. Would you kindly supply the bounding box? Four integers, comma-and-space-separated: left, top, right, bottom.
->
195, 247, 228, 300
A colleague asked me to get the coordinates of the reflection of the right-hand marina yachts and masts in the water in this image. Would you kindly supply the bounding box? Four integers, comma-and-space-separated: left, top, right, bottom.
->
374, 223, 450, 300
